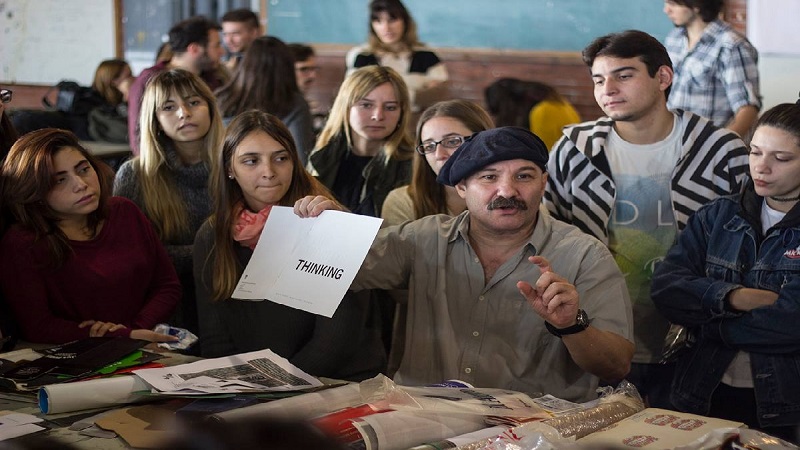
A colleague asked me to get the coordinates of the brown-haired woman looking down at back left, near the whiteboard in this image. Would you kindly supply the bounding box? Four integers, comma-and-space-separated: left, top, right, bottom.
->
89, 59, 134, 144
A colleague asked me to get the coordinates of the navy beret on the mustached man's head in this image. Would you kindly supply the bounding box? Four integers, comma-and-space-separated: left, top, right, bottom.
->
436, 127, 548, 186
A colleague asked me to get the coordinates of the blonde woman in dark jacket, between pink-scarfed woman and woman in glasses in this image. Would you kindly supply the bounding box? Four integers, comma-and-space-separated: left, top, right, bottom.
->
308, 66, 414, 217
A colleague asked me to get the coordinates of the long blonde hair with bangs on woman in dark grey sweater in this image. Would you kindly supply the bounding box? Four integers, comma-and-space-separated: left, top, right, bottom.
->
133, 69, 224, 241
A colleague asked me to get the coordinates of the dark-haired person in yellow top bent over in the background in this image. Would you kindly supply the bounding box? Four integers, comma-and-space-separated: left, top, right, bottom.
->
484, 78, 581, 149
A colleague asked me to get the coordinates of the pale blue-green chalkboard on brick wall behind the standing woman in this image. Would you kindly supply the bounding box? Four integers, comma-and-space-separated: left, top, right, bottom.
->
267, 0, 672, 51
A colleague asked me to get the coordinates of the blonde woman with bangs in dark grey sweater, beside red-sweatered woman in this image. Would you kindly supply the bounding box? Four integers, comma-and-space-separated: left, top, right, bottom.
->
114, 69, 223, 338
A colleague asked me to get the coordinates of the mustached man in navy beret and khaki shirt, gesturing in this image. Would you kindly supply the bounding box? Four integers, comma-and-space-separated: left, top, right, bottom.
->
344, 127, 633, 401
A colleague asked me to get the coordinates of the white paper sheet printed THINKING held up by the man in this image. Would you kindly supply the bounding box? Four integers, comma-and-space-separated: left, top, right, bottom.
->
233, 206, 382, 317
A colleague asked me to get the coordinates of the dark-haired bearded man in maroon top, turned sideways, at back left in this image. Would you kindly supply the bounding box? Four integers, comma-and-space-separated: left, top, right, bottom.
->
128, 16, 225, 155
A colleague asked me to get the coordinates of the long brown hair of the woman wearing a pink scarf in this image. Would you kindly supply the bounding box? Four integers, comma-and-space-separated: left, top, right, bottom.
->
209, 110, 333, 300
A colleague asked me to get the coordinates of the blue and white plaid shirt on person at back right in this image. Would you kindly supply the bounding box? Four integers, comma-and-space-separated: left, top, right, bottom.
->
665, 20, 761, 127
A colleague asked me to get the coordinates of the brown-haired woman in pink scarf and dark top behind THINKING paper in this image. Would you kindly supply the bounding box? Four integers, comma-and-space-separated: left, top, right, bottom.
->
194, 111, 386, 380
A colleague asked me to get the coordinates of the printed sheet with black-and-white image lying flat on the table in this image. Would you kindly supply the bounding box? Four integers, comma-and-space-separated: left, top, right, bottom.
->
133, 349, 322, 395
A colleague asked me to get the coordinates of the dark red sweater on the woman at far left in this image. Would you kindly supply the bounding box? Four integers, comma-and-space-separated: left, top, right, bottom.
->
0, 197, 181, 344
